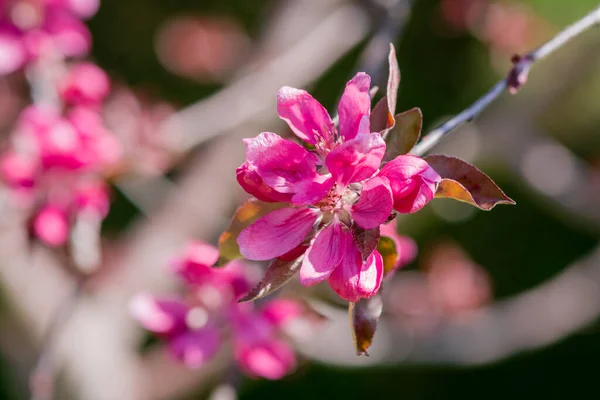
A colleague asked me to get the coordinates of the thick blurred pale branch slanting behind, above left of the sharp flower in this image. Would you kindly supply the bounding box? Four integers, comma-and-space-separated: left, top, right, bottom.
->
160, 0, 367, 153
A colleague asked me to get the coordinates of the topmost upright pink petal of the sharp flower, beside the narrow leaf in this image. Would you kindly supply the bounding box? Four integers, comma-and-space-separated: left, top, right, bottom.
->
338, 72, 371, 140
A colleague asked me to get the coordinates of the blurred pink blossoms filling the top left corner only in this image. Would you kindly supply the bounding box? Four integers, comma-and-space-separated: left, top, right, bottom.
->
0, 0, 100, 74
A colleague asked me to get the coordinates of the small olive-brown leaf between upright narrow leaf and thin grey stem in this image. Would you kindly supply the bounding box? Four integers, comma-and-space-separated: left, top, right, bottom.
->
384, 107, 423, 161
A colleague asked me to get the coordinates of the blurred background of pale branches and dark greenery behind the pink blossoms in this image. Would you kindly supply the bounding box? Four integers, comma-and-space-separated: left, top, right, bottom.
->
0, 0, 600, 400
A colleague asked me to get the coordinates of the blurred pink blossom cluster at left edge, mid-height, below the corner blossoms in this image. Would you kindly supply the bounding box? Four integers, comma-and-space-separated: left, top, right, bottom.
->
0, 99, 121, 246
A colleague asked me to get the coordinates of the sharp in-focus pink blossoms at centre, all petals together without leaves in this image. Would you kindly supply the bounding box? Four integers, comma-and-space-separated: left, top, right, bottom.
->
237, 73, 441, 302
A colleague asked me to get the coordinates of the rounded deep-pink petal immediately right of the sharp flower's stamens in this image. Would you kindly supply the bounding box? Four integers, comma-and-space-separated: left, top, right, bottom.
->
350, 176, 394, 229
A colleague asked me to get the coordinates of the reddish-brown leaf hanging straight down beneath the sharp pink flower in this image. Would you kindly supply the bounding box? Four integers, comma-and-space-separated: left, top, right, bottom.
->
348, 294, 383, 356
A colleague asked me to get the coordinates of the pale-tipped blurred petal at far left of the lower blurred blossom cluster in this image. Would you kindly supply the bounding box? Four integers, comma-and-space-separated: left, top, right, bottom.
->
129, 293, 188, 335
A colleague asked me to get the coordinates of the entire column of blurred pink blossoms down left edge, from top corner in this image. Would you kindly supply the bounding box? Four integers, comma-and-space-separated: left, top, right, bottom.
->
0, 0, 122, 246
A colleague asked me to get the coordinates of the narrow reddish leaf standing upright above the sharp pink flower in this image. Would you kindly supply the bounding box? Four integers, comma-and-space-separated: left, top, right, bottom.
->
371, 43, 400, 135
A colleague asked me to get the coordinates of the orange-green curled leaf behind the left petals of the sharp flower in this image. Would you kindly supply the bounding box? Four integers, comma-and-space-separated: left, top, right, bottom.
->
217, 199, 288, 266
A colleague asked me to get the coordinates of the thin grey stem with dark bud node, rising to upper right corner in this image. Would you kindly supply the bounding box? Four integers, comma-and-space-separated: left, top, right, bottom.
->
410, 6, 600, 156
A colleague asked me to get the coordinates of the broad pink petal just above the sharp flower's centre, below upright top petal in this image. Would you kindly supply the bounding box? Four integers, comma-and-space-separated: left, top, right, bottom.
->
325, 133, 385, 185
